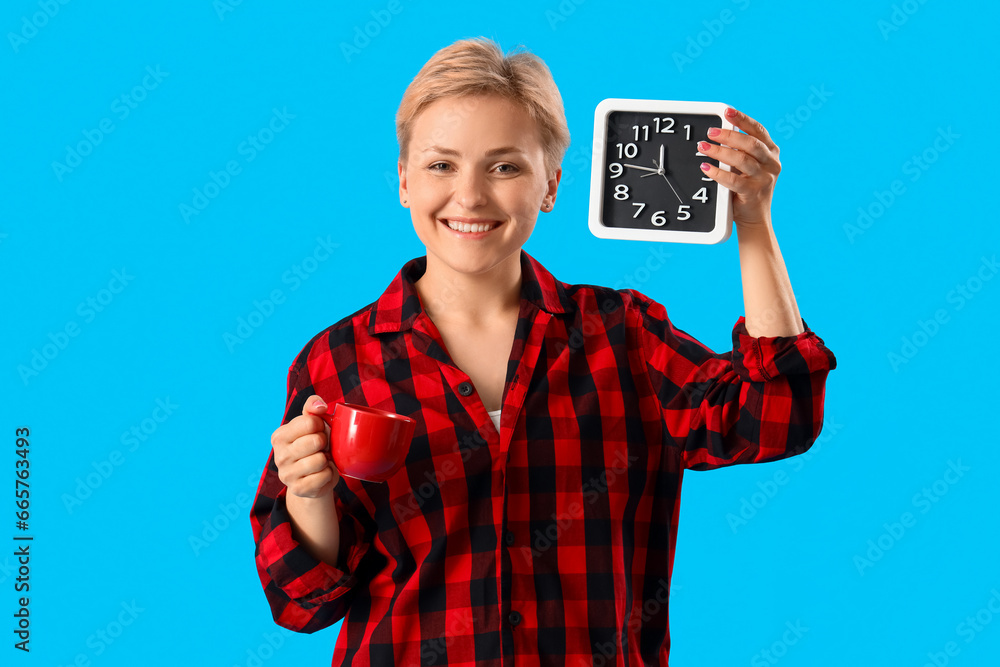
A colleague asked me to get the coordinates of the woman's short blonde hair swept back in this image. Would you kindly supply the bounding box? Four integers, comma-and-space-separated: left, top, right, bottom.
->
396, 37, 569, 174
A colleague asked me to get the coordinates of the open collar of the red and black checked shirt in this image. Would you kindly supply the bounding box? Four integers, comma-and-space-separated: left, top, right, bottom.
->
368, 248, 572, 335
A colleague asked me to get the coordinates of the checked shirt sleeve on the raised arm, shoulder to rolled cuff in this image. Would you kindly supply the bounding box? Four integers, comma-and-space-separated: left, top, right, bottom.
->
629, 290, 837, 470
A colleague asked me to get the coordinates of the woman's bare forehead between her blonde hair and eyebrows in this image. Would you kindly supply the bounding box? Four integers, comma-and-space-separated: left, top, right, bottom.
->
413, 95, 541, 152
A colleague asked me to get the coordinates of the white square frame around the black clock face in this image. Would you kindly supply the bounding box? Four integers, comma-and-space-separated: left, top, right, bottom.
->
589, 97, 734, 244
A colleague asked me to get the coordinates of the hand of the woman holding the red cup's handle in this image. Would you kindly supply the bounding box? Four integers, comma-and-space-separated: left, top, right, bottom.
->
271, 395, 340, 498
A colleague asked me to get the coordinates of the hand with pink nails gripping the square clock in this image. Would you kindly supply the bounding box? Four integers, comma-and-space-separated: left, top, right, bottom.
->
698, 107, 781, 231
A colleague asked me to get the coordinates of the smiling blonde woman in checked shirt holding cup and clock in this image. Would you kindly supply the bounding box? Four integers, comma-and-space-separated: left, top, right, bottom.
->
251, 39, 836, 666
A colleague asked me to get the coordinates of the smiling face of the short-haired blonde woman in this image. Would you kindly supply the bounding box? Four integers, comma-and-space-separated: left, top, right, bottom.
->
399, 95, 562, 274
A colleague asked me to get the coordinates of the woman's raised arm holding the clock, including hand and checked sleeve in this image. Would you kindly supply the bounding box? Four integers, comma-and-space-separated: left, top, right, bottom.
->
634, 109, 837, 470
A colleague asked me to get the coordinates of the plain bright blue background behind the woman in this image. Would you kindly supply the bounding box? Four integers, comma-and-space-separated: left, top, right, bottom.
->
0, 0, 1000, 667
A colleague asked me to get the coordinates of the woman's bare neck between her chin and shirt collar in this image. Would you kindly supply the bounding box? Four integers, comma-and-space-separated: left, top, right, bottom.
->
414, 252, 521, 326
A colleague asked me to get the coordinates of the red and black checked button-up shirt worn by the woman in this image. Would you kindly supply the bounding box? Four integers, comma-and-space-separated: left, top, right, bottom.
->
250, 250, 836, 667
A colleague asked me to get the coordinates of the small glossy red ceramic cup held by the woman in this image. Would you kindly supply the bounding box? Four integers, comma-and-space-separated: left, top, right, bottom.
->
316, 403, 417, 482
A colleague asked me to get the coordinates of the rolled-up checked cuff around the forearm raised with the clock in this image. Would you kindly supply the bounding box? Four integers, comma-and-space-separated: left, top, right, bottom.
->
733, 315, 837, 382
